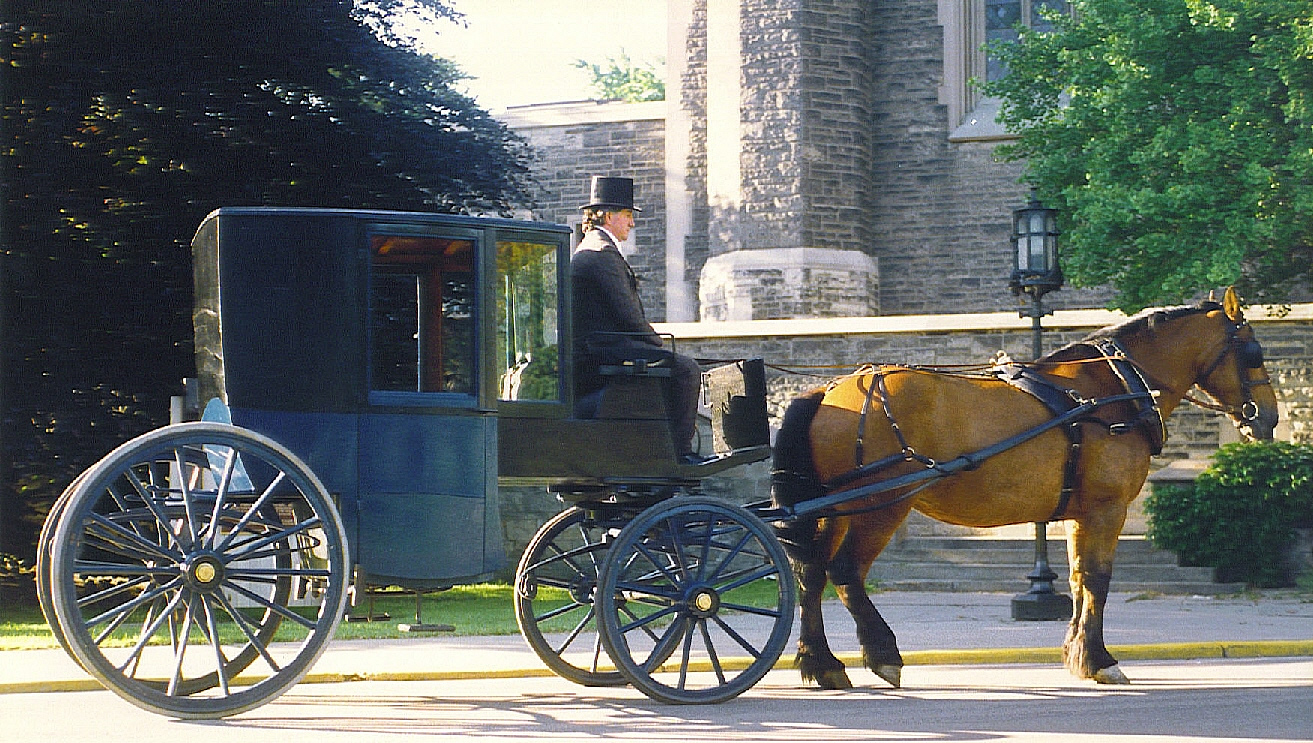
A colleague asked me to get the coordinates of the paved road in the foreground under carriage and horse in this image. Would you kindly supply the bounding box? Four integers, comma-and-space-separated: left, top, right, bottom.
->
0, 658, 1313, 743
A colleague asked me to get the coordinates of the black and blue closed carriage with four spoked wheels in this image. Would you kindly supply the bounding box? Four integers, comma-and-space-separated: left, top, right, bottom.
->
38, 207, 794, 718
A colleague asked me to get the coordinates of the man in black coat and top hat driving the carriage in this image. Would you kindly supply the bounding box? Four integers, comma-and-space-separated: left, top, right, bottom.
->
570, 176, 702, 463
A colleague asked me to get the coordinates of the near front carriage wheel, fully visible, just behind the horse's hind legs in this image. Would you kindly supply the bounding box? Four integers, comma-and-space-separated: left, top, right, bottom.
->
597, 496, 796, 704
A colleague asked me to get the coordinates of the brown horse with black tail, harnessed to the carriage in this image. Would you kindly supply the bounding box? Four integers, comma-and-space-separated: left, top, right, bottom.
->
772, 289, 1278, 689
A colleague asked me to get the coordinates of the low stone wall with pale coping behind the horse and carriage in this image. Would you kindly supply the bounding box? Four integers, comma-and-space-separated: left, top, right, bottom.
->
502, 306, 1313, 564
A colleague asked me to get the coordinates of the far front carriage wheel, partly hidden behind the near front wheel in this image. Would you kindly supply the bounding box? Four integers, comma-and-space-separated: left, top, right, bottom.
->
515, 507, 625, 687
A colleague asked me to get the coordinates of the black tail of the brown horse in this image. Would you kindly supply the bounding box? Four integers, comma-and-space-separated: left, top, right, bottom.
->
771, 389, 825, 563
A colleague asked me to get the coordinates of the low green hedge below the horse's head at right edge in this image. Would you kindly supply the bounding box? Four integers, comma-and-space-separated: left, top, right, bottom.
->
1145, 441, 1313, 587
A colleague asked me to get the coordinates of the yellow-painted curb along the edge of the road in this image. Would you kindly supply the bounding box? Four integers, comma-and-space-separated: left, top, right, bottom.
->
0, 639, 1313, 694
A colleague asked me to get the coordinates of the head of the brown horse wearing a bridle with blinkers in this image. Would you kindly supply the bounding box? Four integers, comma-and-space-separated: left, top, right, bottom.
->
1195, 287, 1278, 441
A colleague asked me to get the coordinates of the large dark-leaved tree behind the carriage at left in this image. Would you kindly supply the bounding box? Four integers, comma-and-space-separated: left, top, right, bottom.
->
0, 0, 528, 569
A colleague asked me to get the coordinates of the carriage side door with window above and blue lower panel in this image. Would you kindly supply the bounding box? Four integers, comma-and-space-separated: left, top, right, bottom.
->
357, 224, 506, 585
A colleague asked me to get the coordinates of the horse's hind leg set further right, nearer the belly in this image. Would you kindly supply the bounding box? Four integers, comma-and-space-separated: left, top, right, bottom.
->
829, 504, 911, 688
